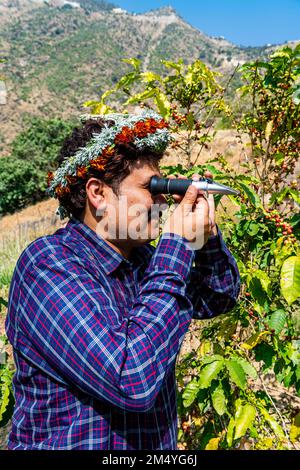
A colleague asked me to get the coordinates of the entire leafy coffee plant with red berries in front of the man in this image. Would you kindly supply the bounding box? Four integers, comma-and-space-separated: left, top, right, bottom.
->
85, 46, 300, 450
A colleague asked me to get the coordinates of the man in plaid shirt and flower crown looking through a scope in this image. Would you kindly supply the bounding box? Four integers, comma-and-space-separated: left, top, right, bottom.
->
6, 112, 239, 450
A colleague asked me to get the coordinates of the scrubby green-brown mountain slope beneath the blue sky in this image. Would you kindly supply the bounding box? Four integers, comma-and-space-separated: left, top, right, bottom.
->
0, 0, 296, 154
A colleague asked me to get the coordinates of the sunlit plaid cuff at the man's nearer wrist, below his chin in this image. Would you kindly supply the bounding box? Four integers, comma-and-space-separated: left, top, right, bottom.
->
149, 233, 195, 279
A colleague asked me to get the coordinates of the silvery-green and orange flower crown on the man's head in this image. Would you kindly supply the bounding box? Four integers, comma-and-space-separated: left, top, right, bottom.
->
46, 111, 171, 219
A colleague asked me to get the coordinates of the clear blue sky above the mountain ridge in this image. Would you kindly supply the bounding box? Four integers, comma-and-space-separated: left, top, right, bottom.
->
112, 0, 300, 46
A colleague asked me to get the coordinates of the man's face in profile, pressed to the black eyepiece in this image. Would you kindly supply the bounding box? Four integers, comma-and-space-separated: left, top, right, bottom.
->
97, 161, 166, 247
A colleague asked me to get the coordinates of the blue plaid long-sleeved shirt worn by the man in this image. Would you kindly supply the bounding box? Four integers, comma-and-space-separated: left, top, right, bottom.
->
6, 218, 240, 450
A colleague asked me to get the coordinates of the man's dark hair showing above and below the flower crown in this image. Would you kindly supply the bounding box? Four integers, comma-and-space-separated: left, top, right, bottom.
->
57, 119, 163, 218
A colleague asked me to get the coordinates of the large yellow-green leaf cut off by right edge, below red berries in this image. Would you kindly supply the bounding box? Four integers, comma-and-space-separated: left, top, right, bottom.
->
280, 256, 300, 305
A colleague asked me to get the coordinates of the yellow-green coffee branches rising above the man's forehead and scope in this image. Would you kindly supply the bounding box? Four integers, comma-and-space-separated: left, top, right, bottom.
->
84, 58, 229, 168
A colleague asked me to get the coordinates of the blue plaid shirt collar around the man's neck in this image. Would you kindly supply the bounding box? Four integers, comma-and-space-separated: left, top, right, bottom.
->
66, 217, 150, 275
